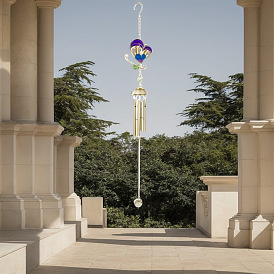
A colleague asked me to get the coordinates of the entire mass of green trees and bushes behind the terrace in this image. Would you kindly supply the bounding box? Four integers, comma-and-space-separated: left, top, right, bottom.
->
55, 64, 243, 227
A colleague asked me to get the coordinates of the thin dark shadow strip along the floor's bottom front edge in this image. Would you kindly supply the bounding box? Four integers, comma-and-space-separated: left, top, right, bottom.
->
29, 266, 250, 274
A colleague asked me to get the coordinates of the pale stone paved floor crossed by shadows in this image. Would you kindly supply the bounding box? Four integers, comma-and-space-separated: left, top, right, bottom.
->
29, 228, 274, 274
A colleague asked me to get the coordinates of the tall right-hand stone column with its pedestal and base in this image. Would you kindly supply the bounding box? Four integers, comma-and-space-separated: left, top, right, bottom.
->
228, 0, 274, 249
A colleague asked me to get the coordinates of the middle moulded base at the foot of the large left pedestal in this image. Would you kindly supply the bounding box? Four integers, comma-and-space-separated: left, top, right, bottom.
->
20, 195, 43, 229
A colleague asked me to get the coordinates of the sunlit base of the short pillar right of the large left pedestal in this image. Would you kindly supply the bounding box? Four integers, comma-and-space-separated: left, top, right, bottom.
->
61, 193, 82, 221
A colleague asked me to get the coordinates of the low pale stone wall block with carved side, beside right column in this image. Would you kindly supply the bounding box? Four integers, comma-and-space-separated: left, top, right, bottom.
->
196, 176, 238, 238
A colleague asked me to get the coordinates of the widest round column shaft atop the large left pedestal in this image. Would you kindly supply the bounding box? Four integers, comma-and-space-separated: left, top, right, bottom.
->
11, 0, 37, 122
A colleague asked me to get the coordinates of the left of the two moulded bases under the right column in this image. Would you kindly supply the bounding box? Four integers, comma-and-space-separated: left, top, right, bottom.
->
228, 214, 255, 248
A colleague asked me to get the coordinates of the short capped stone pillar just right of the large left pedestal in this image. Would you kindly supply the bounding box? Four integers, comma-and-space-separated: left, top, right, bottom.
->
55, 136, 82, 221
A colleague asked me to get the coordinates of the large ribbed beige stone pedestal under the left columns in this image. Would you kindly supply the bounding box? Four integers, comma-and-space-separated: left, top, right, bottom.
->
0, 122, 64, 230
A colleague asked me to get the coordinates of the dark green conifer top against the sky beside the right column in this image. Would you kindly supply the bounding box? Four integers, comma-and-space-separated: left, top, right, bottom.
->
178, 73, 243, 131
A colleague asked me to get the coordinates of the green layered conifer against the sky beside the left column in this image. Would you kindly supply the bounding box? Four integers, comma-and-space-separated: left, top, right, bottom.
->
54, 61, 113, 139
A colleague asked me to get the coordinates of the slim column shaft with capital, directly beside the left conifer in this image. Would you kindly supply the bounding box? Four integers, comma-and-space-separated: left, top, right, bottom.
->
36, 0, 61, 123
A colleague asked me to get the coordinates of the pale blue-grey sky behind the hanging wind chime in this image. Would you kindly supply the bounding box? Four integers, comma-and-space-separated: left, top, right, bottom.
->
54, 0, 244, 138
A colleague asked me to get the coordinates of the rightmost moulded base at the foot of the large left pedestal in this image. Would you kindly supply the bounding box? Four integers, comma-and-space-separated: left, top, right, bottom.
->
38, 194, 64, 228
